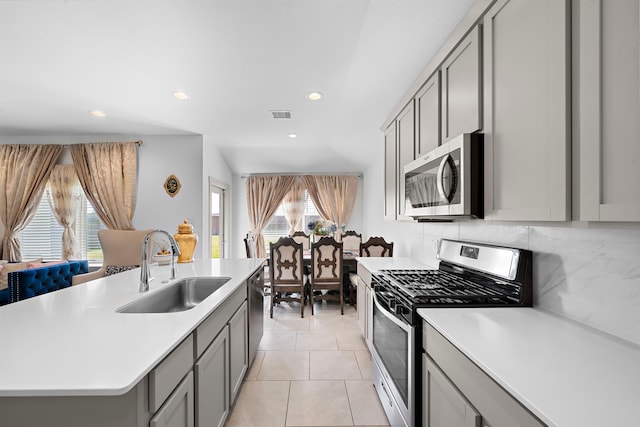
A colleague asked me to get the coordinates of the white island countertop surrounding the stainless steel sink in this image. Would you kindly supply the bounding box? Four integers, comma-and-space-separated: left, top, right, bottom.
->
0, 258, 263, 396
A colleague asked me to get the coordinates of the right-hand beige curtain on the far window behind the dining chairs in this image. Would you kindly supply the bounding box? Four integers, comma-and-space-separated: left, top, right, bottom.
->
302, 175, 358, 239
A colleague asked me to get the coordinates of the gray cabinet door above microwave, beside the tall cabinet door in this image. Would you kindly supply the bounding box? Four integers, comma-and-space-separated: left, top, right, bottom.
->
442, 27, 482, 142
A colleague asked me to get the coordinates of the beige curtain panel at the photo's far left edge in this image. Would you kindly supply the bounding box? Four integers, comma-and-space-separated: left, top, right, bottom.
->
0, 144, 62, 261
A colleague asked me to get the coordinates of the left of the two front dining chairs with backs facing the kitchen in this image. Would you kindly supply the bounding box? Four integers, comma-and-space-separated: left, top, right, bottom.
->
269, 237, 305, 317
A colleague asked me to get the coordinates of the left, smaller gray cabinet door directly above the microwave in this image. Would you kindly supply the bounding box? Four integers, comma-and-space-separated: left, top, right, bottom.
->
415, 71, 440, 159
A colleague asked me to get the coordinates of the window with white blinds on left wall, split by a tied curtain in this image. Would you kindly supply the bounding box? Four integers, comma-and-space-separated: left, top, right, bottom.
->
19, 189, 106, 265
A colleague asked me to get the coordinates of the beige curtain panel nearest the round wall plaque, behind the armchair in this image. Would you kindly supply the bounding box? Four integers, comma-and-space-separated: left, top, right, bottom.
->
70, 142, 138, 230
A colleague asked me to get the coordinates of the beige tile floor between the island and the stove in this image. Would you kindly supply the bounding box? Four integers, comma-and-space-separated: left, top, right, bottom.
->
225, 296, 389, 427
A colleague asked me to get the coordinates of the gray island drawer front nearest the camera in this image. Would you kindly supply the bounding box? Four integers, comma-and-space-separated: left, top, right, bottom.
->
149, 335, 194, 413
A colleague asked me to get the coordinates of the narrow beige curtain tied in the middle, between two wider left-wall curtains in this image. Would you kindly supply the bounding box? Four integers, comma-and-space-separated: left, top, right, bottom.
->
47, 165, 82, 259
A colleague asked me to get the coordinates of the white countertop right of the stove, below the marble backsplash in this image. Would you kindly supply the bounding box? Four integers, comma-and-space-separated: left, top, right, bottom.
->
418, 308, 640, 427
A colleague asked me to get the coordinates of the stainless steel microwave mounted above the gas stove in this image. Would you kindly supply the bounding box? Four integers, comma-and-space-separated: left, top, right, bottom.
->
404, 134, 484, 221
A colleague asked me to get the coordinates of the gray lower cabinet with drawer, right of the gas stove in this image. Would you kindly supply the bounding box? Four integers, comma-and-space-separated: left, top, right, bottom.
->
422, 322, 545, 427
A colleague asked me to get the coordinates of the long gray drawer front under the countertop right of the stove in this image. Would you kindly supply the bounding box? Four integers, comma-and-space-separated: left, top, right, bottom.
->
423, 322, 544, 427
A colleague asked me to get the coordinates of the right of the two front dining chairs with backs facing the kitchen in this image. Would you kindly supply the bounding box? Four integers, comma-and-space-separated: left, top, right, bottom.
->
309, 237, 344, 315
